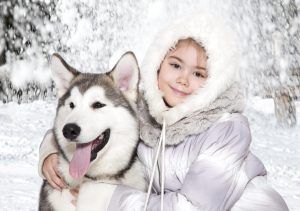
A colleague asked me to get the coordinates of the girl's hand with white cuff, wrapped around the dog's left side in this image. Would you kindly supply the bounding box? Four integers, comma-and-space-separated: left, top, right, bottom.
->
38, 130, 66, 190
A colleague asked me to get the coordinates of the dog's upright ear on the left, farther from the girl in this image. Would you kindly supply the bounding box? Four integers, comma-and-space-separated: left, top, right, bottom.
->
51, 53, 79, 98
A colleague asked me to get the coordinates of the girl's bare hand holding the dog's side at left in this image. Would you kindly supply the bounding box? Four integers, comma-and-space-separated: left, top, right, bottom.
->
42, 153, 67, 191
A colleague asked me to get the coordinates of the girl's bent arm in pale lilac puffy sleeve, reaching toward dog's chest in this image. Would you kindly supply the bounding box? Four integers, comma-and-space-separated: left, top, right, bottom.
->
108, 116, 265, 211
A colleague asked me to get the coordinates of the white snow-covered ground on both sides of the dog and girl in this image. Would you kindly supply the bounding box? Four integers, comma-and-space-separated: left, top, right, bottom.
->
0, 98, 300, 211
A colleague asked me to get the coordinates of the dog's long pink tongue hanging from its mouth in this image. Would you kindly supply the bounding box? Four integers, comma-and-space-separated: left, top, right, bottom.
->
69, 143, 92, 179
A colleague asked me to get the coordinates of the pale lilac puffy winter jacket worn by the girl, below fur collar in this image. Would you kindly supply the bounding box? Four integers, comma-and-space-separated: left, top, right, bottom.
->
108, 114, 288, 211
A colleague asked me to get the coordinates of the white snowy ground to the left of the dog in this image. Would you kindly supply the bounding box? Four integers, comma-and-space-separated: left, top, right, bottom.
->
0, 101, 56, 211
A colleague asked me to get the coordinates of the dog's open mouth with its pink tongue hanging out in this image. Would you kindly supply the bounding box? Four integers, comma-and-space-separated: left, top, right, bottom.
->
69, 129, 110, 179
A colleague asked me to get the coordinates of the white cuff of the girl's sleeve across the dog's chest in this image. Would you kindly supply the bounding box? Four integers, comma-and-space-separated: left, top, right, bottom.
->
77, 182, 117, 211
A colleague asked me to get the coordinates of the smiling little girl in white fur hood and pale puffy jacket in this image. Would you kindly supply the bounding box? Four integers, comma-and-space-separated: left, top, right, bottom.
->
40, 13, 288, 211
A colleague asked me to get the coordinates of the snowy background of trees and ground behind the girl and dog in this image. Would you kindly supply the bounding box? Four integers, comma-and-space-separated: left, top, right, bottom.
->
0, 0, 300, 211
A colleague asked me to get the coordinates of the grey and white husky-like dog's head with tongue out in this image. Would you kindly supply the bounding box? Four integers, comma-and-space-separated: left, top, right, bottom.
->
51, 52, 139, 179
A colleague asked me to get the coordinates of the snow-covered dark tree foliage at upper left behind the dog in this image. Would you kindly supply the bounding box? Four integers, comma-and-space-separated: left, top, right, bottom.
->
0, 0, 56, 103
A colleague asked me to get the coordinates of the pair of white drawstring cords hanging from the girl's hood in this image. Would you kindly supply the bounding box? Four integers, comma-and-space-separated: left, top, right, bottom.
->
143, 119, 166, 211
